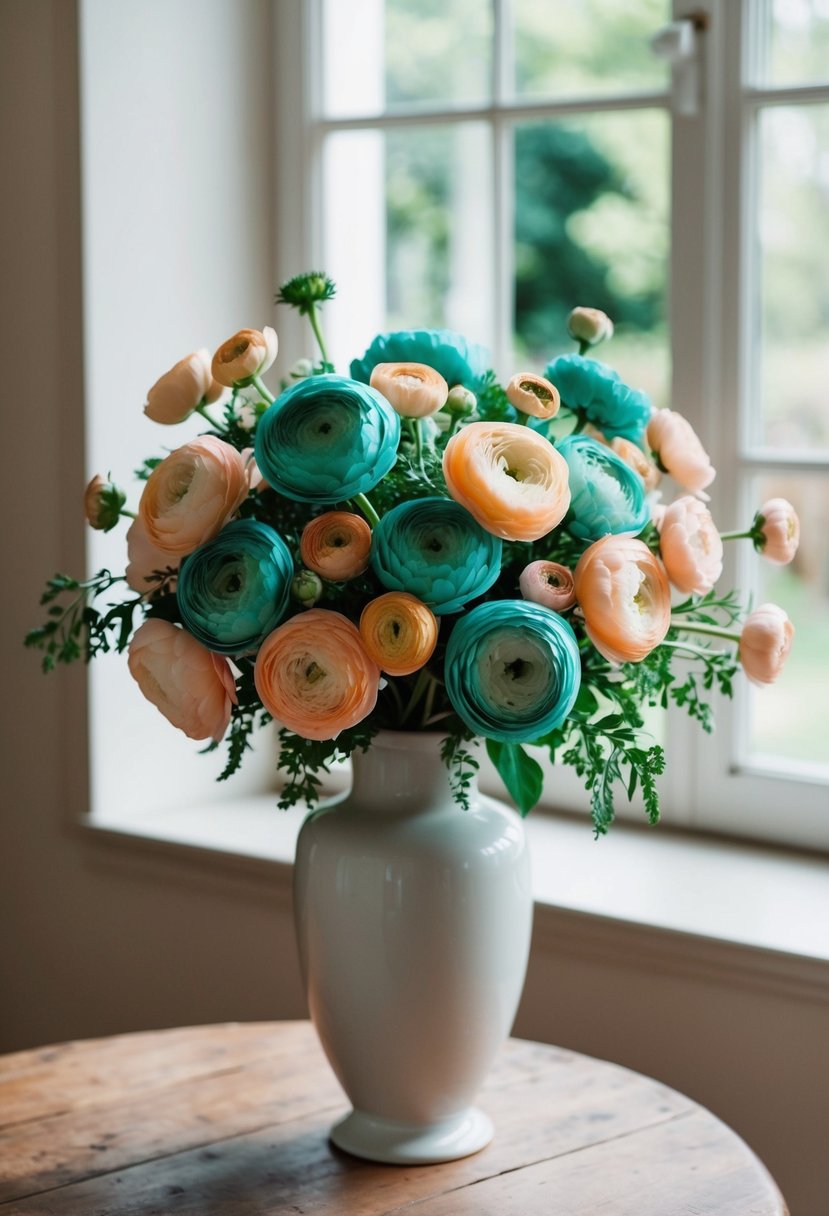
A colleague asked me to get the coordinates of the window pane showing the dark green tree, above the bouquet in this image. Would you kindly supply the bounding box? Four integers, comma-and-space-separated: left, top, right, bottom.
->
513, 109, 670, 406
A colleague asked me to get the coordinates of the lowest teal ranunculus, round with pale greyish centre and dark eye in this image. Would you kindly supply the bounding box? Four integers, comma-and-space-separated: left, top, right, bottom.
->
444, 599, 581, 743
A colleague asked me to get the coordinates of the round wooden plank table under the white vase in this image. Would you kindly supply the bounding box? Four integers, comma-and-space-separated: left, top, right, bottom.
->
0, 1021, 786, 1216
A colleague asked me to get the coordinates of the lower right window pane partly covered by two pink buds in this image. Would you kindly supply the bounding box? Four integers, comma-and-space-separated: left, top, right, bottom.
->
749, 474, 829, 776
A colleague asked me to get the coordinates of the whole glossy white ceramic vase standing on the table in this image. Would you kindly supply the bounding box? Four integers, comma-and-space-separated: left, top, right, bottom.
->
294, 731, 532, 1164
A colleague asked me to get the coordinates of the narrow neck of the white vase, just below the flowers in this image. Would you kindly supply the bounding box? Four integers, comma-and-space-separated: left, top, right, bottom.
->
351, 731, 476, 815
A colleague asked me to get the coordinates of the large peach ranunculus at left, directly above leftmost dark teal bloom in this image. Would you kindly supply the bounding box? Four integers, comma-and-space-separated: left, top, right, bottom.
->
139, 435, 248, 557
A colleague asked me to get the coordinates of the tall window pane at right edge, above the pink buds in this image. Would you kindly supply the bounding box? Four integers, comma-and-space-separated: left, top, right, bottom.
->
752, 105, 829, 449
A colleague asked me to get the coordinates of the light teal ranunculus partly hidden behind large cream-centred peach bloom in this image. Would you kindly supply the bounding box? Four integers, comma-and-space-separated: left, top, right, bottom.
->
556, 435, 650, 541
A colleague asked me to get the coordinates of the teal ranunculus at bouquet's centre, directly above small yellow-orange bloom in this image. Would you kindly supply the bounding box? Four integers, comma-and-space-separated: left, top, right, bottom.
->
371, 497, 502, 617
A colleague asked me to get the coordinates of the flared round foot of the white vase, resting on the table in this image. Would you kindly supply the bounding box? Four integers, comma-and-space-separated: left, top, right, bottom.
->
331, 1107, 492, 1165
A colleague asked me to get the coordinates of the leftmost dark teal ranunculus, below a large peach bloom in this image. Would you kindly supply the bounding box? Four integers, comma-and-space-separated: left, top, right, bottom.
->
176, 519, 294, 654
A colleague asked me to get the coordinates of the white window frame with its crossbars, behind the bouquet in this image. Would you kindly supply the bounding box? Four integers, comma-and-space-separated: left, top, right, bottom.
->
277, 0, 829, 849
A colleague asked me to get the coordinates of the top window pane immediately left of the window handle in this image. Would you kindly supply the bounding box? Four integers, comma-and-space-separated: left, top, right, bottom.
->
512, 0, 671, 98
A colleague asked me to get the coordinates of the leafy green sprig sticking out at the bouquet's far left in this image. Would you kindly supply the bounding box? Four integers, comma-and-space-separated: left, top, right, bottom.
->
24, 570, 141, 671
